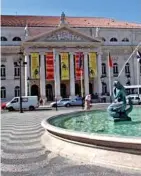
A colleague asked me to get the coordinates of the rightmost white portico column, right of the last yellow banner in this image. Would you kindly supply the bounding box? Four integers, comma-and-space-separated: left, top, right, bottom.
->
97, 52, 102, 96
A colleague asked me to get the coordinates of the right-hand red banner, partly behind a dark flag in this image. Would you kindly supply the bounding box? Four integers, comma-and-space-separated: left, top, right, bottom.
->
75, 53, 84, 80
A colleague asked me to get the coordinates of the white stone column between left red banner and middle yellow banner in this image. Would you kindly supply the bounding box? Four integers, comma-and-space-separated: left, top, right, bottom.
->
54, 53, 61, 99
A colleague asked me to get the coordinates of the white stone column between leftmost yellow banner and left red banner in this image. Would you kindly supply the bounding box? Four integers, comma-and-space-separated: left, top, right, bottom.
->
40, 53, 46, 100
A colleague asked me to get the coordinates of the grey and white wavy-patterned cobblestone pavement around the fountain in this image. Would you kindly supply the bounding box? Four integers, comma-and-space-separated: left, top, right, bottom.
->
1, 110, 141, 176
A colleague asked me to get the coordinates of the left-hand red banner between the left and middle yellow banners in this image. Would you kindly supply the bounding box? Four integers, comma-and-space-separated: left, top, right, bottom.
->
46, 52, 54, 80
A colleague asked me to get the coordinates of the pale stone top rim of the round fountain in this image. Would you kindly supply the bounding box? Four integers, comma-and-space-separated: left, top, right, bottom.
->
41, 109, 141, 145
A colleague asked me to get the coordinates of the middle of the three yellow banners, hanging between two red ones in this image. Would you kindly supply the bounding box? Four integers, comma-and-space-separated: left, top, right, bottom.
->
61, 53, 70, 80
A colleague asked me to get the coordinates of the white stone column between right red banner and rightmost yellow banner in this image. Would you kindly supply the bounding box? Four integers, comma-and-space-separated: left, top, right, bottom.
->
84, 53, 89, 96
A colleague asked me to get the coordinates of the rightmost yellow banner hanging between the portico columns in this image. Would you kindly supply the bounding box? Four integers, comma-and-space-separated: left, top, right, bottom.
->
89, 53, 97, 78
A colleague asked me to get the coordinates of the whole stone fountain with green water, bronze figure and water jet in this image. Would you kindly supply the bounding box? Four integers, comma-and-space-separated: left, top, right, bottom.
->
41, 45, 141, 171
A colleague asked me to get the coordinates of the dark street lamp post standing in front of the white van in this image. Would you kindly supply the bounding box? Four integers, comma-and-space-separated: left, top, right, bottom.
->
14, 49, 27, 113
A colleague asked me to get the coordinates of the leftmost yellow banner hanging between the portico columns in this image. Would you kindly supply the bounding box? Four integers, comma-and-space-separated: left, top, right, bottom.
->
31, 53, 40, 79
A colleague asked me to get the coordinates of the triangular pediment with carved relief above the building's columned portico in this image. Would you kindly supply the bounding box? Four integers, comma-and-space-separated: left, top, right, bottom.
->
26, 25, 101, 43
